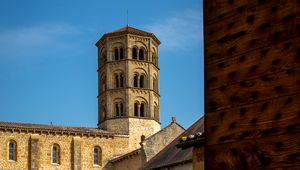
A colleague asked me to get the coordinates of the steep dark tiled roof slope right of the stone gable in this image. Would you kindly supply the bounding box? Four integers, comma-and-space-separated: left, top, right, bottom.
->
142, 117, 204, 170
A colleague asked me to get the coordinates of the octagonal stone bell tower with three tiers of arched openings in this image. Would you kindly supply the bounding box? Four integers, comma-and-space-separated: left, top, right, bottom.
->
96, 26, 160, 149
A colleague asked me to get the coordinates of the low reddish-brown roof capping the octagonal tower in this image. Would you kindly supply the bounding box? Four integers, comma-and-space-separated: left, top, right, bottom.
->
96, 26, 160, 46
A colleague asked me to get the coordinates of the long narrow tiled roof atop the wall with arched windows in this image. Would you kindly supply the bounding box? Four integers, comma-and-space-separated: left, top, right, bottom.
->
0, 122, 119, 135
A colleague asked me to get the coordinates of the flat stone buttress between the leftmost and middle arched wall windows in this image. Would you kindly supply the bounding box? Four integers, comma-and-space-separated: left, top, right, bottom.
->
29, 134, 39, 170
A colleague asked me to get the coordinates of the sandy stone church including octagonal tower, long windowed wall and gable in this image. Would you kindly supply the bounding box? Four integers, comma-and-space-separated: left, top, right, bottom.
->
0, 26, 184, 170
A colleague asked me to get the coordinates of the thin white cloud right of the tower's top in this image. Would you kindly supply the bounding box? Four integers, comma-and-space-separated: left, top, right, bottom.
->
145, 9, 203, 51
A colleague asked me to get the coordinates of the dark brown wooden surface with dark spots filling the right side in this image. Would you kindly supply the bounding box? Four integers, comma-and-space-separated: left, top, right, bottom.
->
204, 0, 300, 169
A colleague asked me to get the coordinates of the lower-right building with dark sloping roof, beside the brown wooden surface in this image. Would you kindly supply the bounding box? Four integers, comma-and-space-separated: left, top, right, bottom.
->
142, 117, 204, 170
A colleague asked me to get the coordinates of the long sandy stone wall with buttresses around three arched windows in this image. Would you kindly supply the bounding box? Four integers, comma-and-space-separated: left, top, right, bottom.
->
0, 131, 128, 170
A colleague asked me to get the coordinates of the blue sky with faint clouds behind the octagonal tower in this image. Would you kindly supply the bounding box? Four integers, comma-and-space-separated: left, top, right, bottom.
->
0, 0, 204, 128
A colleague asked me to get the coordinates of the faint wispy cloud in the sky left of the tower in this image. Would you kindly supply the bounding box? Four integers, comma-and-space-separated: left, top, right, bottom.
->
0, 23, 82, 61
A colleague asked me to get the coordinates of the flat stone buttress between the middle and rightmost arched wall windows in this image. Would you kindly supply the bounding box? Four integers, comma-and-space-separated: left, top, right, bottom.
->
72, 137, 81, 170
